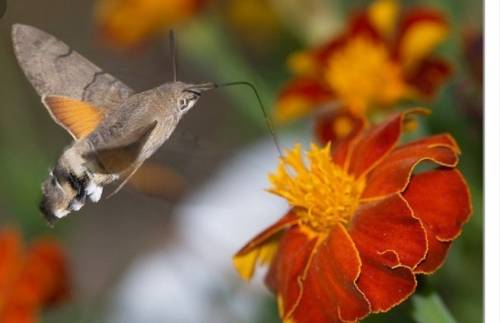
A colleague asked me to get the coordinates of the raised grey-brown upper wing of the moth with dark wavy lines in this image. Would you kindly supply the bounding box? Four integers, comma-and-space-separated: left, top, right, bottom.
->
12, 24, 134, 110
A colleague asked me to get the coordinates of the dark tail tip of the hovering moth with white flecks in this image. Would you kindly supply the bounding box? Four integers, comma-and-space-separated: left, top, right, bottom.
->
40, 171, 77, 225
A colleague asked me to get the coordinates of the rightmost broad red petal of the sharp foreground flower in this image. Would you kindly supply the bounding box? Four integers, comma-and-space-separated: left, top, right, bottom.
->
403, 169, 472, 273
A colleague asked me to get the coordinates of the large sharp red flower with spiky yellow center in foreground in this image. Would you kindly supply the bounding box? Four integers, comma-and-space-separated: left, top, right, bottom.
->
234, 110, 471, 323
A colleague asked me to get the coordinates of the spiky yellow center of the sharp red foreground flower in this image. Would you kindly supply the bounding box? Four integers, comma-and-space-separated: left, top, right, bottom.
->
269, 144, 364, 233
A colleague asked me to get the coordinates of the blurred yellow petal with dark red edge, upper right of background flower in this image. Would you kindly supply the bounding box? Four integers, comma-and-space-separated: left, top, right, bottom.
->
397, 8, 449, 69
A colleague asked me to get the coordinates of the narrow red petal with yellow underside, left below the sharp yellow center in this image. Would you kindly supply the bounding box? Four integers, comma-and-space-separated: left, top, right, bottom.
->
233, 211, 298, 280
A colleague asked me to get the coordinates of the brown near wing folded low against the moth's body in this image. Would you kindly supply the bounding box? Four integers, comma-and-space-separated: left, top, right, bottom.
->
83, 121, 158, 174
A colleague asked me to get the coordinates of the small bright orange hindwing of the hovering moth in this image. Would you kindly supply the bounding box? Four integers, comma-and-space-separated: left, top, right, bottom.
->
42, 95, 103, 139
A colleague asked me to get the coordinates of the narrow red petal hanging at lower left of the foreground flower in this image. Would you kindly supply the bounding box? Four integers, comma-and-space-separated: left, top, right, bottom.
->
266, 226, 318, 317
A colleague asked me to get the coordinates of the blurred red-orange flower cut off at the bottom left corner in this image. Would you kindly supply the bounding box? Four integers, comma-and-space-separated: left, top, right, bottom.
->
0, 230, 69, 323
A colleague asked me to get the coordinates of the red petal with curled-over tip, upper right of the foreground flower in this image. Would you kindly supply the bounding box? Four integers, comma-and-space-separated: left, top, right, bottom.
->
362, 134, 459, 199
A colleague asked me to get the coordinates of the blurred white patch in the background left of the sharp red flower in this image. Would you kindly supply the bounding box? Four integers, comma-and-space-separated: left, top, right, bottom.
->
107, 133, 308, 323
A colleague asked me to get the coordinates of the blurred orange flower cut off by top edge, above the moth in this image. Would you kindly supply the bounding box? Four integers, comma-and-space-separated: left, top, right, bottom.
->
96, 0, 208, 48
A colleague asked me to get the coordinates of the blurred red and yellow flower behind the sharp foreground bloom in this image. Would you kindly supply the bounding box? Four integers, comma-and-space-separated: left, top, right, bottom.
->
276, 0, 450, 122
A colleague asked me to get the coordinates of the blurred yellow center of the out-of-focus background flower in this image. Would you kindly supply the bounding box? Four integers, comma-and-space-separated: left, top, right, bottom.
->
325, 36, 407, 114
